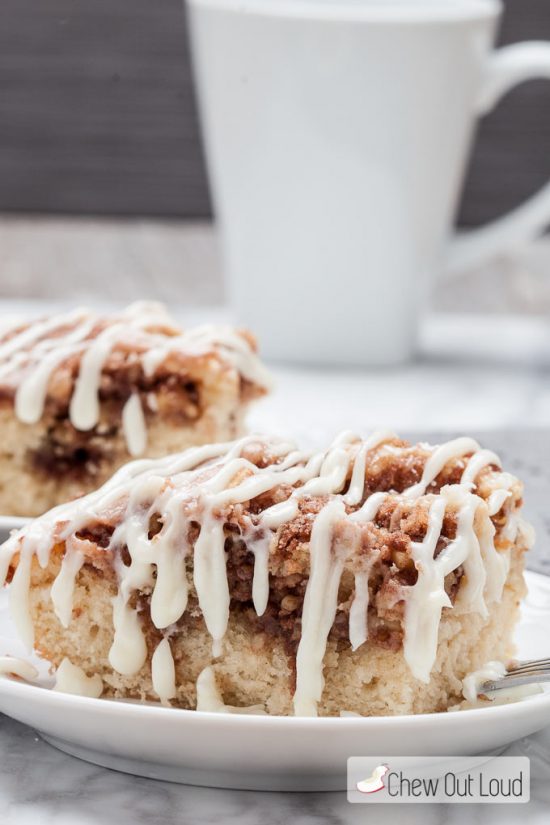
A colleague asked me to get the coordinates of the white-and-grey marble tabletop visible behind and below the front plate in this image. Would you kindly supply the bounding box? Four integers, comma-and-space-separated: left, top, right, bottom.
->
0, 294, 550, 825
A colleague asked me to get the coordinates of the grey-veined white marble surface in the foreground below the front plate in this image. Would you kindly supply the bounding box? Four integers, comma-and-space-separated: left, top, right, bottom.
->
0, 716, 550, 825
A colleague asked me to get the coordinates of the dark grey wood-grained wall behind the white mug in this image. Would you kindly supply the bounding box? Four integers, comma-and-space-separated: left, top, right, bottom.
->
0, 0, 550, 225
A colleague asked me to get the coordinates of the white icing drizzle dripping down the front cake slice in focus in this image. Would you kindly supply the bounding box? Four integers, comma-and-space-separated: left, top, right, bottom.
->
0, 432, 529, 715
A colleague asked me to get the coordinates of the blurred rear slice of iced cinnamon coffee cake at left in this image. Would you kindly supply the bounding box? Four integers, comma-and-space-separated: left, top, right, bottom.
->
0, 303, 268, 516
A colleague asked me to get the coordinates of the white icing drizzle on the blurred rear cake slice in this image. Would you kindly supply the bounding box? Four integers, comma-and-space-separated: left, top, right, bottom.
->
0, 302, 271, 456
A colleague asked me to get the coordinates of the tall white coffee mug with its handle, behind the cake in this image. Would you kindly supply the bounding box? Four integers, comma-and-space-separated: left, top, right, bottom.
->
188, 0, 550, 364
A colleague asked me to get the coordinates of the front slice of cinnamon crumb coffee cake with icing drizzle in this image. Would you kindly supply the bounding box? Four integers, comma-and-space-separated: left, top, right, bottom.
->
0, 432, 532, 716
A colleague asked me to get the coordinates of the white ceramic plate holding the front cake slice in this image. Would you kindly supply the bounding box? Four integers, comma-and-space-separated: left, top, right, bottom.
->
0, 573, 550, 790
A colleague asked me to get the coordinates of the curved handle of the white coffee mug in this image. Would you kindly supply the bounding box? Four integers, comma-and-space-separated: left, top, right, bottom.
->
444, 41, 550, 276
